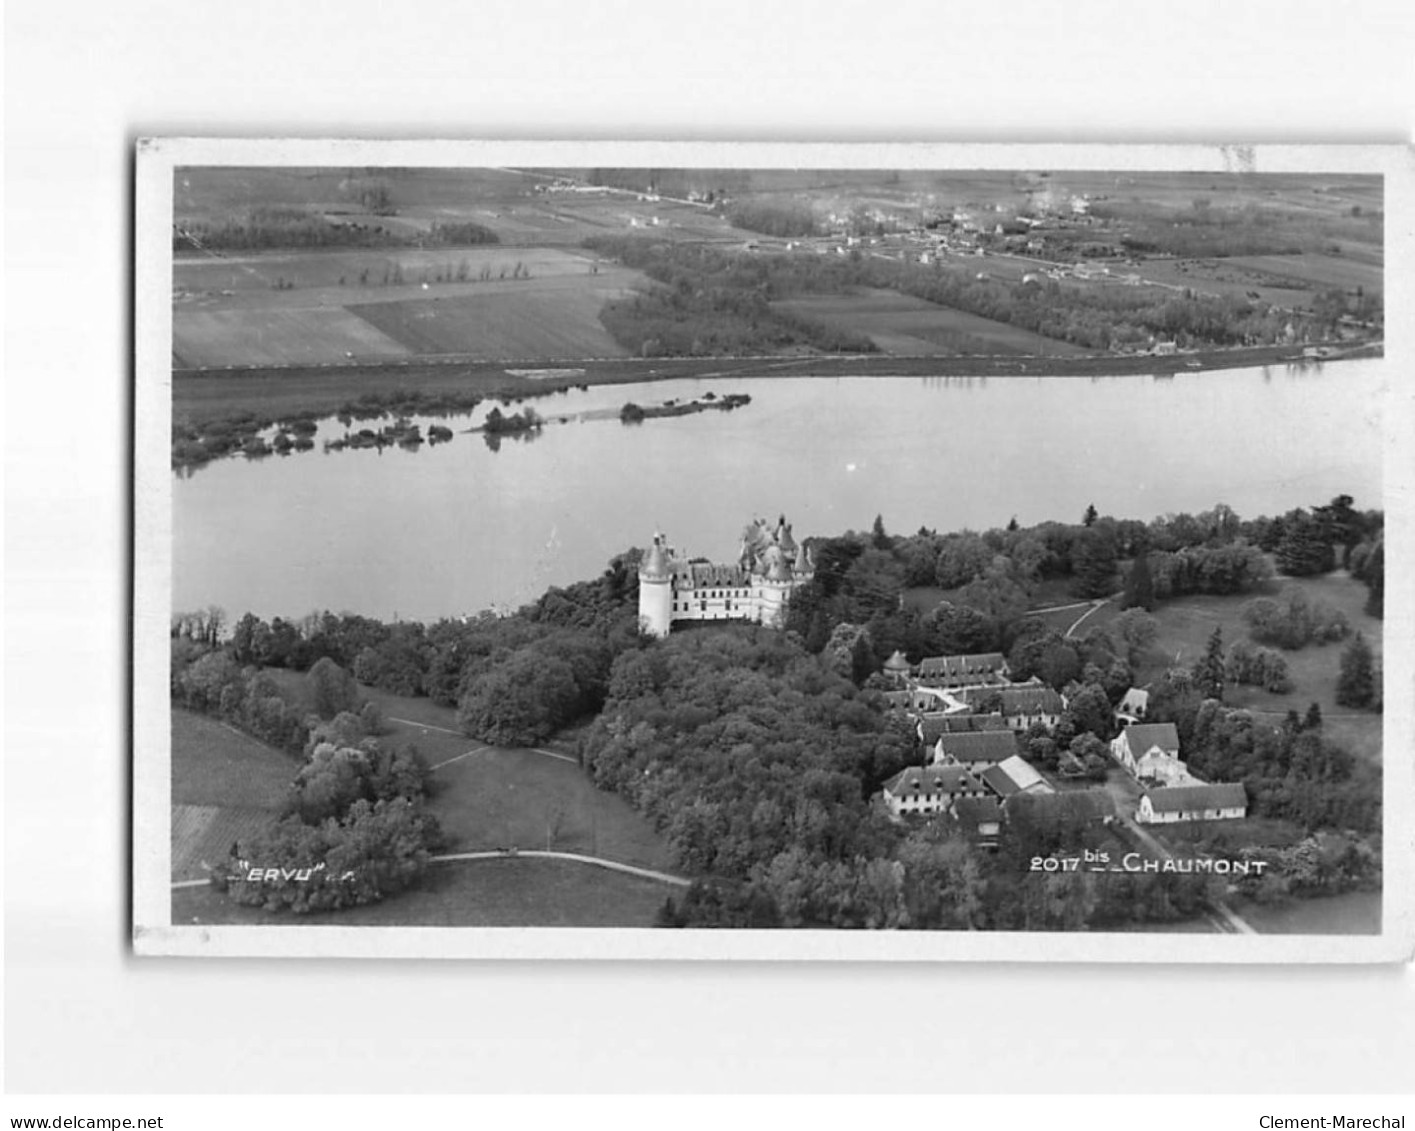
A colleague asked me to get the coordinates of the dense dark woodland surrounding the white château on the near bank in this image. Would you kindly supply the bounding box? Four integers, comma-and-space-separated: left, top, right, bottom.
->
173, 495, 1384, 929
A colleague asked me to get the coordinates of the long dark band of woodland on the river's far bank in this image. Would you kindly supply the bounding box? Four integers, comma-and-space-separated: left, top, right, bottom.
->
587, 236, 1374, 355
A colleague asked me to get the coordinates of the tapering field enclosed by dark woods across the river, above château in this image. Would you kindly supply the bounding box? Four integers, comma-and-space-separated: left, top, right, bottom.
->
773, 290, 1088, 357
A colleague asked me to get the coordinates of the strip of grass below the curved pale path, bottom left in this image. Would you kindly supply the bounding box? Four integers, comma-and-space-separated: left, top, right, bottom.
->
171, 858, 676, 927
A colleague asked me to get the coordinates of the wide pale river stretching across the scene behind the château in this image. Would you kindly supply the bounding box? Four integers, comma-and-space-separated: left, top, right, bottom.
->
173, 358, 1391, 620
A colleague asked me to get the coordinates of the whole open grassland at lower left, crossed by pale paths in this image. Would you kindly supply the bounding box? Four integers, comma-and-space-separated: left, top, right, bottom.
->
173, 682, 672, 926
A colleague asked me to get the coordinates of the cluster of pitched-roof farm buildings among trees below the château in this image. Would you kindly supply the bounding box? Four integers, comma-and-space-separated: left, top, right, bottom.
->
876, 651, 1248, 846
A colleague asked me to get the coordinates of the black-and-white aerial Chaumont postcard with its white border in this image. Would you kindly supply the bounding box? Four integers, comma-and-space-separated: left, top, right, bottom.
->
134, 139, 1411, 961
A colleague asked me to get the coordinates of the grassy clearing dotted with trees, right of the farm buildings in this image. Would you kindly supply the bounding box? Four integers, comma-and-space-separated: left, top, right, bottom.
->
1137, 572, 1381, 762
